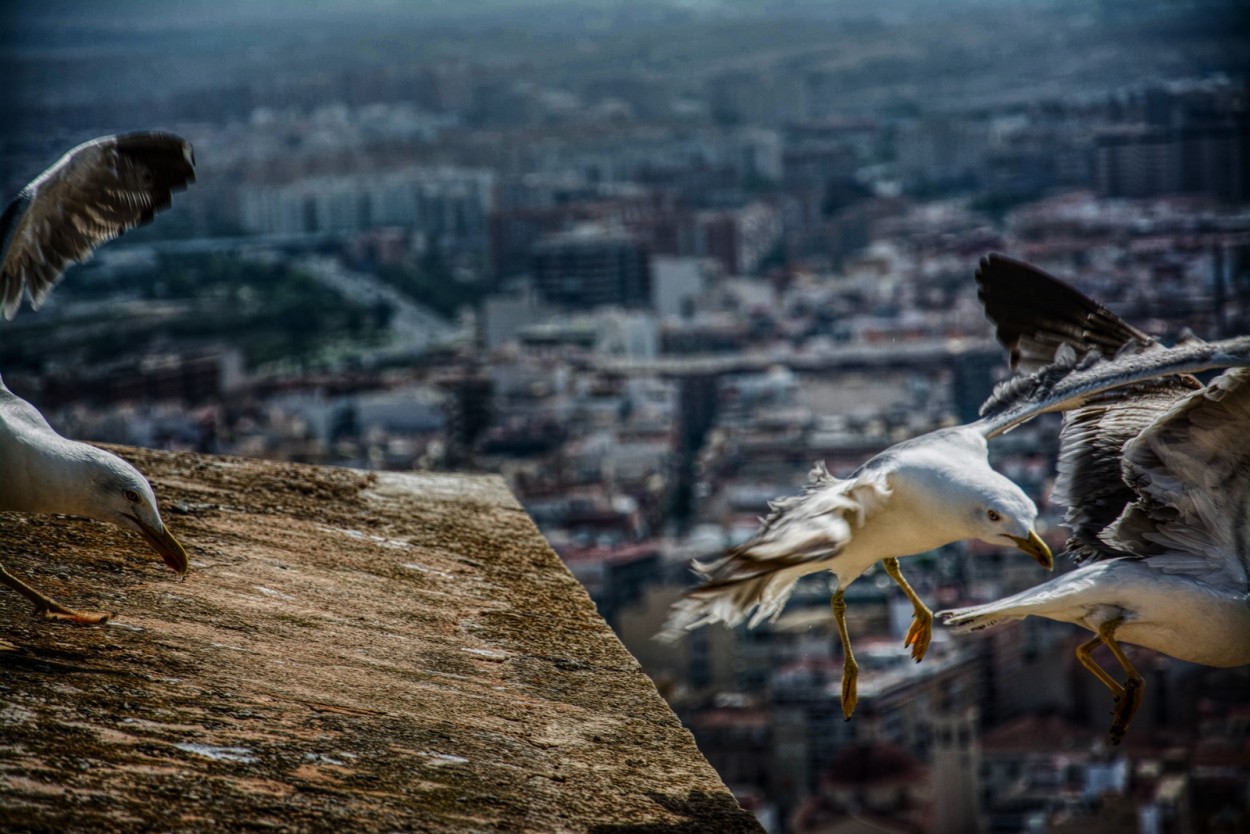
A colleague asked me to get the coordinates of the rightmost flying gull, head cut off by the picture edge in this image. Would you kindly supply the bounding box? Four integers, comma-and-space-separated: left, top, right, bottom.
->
940, 255, 1250, 743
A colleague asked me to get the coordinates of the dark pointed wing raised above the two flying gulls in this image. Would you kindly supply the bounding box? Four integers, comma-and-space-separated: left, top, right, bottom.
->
976, 253, 1155, 374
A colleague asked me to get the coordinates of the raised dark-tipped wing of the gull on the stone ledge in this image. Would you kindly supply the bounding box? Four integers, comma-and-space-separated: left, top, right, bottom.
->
0, 133, 195, 319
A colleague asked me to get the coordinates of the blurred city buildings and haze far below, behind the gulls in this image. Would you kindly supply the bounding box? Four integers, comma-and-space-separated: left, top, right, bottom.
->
0, 0, 1250, 834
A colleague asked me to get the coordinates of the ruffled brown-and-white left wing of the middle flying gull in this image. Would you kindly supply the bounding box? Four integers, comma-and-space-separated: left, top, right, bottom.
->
660, 463, 890, 639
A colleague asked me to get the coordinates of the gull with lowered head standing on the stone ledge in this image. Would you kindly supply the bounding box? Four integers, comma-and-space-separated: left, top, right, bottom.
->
0, 133, 195, 624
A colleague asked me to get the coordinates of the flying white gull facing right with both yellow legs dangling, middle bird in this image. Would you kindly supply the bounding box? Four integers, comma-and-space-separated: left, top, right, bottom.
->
660, 268, 1250, 719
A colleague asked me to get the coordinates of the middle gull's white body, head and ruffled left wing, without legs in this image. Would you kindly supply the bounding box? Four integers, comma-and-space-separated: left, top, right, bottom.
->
664, 426, 1049, 638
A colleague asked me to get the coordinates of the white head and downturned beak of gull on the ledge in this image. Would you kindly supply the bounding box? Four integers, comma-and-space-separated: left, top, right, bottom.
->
80, 446, 189, 575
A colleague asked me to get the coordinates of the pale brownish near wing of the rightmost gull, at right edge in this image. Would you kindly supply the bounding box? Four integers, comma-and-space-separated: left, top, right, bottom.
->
1101, 368, 1250, 590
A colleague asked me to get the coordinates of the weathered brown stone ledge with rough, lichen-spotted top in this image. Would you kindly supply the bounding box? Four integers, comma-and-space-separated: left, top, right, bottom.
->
0, 449, 760, 833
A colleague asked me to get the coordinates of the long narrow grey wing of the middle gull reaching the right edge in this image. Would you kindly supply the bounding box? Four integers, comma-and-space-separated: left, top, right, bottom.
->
973, 336, 1250, 438
